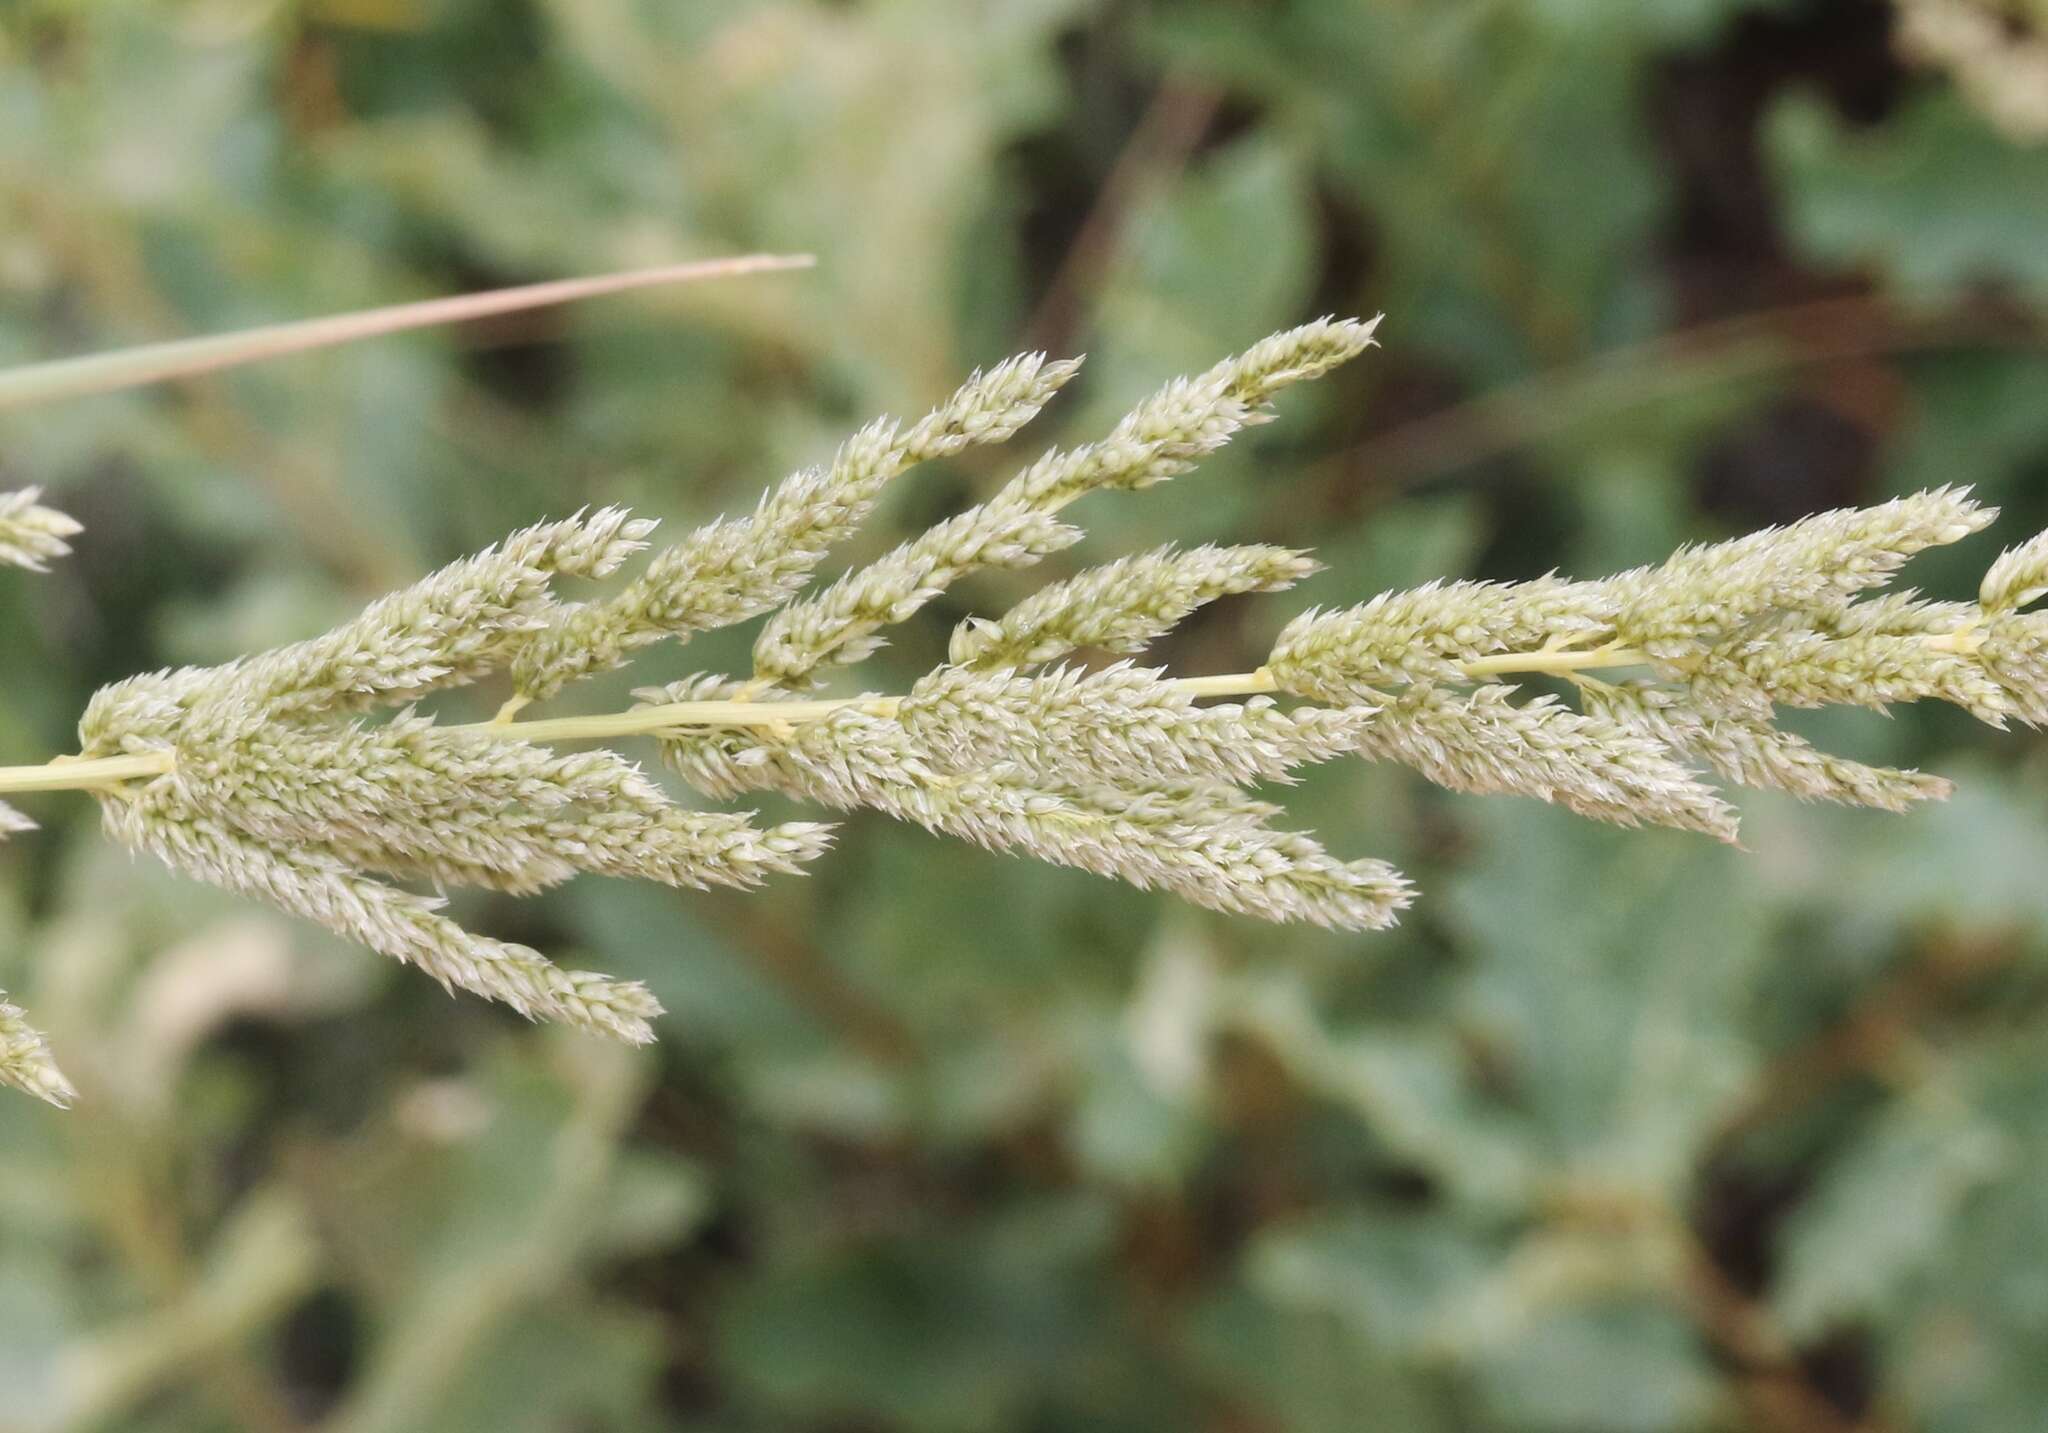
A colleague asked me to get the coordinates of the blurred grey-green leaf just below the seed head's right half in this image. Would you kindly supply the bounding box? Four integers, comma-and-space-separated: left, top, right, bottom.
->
1448, 796, 1772, 1193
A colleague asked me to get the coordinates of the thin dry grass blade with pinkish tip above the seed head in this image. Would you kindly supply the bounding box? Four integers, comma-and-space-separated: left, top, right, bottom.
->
0, 254, 815, 409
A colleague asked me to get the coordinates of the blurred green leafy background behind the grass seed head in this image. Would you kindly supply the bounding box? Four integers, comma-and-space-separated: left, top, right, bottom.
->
0, 0, 2048, 1433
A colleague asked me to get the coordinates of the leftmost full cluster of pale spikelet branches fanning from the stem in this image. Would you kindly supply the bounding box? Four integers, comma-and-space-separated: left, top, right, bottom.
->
68, 510, 825, 1040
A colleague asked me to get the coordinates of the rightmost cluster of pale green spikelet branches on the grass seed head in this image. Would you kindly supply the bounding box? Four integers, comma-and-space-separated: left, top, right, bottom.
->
1266, 489, 2048, 839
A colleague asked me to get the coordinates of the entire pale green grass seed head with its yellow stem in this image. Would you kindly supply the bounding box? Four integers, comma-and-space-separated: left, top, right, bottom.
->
0, 319, 2048, 1099
